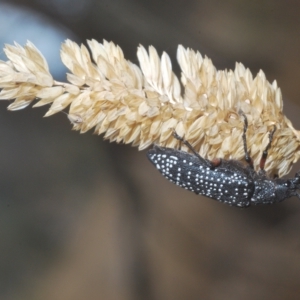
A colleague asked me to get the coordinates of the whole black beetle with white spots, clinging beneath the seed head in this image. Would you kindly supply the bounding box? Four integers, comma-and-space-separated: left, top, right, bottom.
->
147, 112, 300, 207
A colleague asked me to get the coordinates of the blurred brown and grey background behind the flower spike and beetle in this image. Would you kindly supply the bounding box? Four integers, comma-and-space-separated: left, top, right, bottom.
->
0, 0, 300, 300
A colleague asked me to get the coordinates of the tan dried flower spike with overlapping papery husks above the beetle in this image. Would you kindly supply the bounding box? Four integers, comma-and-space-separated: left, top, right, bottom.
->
0, 40, 300, 176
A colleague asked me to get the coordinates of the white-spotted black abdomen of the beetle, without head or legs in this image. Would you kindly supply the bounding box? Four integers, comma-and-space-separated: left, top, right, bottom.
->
148, 146, 254, 207
